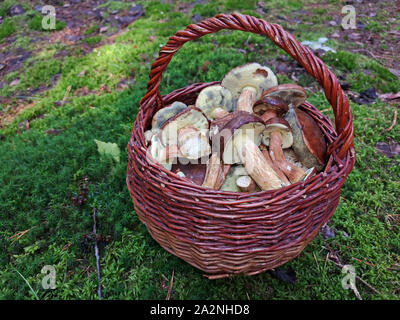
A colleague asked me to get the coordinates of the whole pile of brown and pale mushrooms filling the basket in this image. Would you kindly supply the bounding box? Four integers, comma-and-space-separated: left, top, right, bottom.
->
144, 63, 326, 192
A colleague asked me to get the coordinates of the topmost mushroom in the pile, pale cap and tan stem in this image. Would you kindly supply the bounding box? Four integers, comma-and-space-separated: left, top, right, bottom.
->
221, 63, 278, 113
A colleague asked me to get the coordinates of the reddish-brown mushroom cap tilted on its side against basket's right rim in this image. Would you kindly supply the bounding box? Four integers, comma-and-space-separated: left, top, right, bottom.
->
285, 105, 326, 171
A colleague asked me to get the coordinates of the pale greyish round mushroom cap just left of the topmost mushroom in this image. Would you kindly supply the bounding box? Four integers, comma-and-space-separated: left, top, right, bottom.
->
196, 84, 235, 120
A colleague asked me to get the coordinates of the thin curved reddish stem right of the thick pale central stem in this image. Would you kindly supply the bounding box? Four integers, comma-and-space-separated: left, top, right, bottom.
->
269, 131, 306, 183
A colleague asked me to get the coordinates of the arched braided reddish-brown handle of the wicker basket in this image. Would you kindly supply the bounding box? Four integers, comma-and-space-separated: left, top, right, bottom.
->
139, 13, 354, 159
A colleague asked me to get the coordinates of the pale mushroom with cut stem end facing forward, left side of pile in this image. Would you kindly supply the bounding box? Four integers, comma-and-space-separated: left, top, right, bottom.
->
159, 106, 211, 159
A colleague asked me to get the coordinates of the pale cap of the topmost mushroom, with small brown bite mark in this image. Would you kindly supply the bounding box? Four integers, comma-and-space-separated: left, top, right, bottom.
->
221, 63, 278, 100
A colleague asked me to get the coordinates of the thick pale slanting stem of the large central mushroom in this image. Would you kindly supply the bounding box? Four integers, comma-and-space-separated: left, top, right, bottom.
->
234, 134, 283, 190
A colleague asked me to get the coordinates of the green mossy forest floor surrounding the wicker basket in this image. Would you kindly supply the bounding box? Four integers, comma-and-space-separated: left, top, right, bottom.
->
0, 0, 400, 300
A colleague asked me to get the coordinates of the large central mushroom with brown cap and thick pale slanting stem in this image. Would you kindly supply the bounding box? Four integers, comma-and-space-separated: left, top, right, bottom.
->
220, 111, 283, 190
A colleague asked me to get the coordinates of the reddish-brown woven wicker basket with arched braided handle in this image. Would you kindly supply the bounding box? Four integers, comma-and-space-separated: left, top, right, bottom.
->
126, 14, 355, 279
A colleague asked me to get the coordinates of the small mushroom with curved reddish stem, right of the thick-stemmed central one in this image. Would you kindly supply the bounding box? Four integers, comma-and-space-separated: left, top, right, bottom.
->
263, 118, 305, 183
